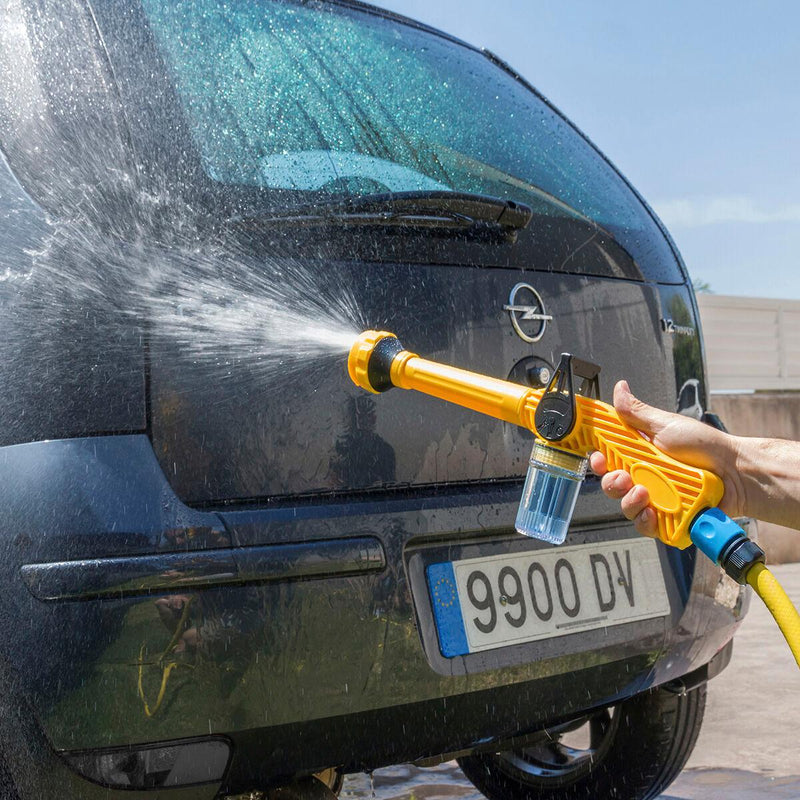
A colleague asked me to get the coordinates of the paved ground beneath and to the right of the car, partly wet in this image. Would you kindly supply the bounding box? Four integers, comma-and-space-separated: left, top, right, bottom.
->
342, 564, 800, 800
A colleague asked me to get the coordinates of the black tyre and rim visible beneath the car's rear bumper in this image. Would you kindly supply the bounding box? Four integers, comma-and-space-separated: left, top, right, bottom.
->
458, 685, 706, 800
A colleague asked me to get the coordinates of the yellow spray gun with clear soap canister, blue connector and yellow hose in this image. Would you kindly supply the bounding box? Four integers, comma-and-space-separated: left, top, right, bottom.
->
347, 331, 800, 666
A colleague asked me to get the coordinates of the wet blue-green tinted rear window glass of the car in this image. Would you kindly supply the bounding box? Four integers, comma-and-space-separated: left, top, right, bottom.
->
142, 0, 682, 282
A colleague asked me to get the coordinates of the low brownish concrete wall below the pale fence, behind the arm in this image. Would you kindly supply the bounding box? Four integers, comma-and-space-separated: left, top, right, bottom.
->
711, 392, 800, 564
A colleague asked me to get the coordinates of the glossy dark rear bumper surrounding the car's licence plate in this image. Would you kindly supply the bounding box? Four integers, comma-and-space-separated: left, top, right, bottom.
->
0, 436, 746, 790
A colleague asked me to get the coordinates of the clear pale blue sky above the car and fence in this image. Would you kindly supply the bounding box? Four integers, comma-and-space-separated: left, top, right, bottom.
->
373, 0, 800, 298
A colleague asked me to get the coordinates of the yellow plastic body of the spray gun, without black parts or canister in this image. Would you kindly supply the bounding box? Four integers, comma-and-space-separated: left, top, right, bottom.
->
348, 331, 723, 549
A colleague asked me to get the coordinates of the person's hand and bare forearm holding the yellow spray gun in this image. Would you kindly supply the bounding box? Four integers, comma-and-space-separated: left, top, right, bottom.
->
590, 381, 800, 537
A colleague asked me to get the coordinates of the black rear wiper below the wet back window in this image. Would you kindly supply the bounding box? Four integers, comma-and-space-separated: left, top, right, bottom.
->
231, 191, 533, 232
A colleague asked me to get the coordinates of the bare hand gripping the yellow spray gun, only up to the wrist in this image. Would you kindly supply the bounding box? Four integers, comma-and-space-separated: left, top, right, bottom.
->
589, 381, 744, 537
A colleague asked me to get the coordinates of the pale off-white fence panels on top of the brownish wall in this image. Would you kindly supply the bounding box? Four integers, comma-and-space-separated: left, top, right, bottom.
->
697, 294, 800, 392
